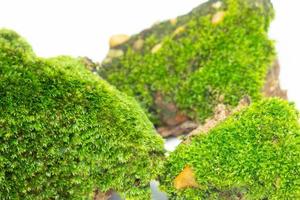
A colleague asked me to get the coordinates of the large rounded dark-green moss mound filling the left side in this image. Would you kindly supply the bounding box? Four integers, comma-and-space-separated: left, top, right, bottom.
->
0, 30, 163, 199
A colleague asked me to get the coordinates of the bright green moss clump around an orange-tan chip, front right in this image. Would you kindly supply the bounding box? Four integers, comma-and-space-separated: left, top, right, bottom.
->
161, 98, 300, 199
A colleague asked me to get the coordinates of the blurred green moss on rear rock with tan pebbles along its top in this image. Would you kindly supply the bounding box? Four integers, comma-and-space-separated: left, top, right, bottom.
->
99, 0, 274, 124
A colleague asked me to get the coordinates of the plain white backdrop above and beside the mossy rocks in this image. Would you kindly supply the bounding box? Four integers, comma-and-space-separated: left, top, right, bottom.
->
0, 0, 300, 107
